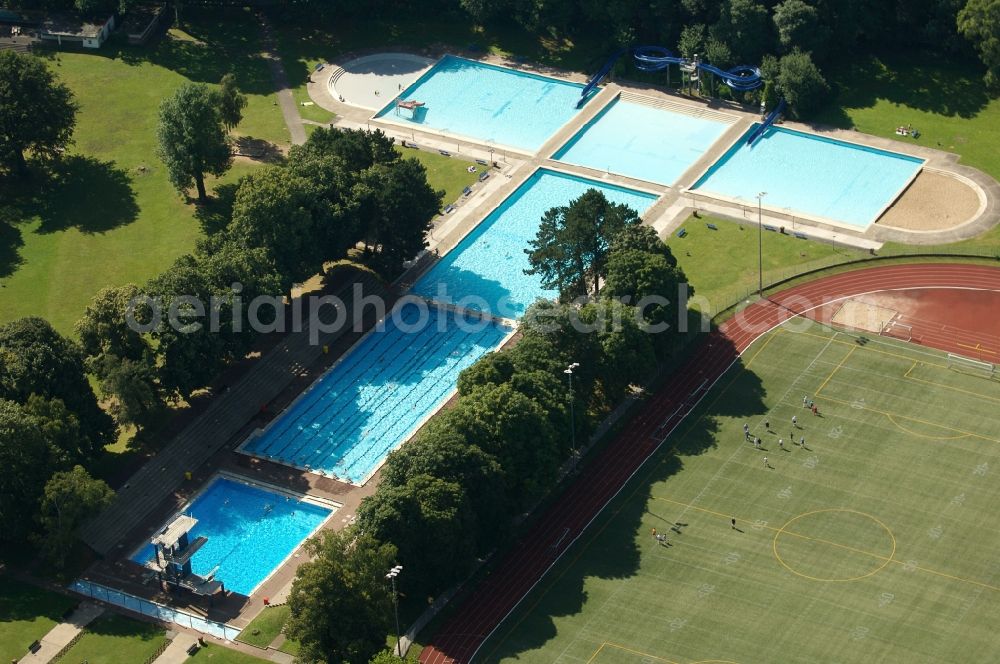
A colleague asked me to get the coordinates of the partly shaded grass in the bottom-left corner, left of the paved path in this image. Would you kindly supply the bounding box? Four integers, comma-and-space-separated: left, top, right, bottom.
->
0, 575, 76, 662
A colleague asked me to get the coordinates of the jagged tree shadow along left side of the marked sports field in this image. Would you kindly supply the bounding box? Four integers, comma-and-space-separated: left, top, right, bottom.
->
472, 334, 767, 661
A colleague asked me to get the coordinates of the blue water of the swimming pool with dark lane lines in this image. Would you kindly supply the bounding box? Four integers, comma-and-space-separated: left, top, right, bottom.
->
243, 302, 510, 484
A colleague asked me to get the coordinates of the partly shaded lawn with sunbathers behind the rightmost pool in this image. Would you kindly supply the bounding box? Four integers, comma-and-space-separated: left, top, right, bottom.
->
816, 53, 1000, 253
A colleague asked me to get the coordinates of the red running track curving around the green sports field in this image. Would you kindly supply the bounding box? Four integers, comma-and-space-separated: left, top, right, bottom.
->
420, 264, 1000, 664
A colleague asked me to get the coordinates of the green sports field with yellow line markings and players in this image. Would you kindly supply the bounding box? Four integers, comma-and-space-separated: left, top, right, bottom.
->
478, 321, 1000, 664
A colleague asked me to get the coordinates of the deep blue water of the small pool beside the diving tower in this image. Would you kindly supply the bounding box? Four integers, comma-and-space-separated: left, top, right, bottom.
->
132, 477, 331, 595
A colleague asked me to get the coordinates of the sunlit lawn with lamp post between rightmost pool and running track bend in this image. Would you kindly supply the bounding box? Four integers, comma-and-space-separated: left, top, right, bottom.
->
667, 214, 865, 315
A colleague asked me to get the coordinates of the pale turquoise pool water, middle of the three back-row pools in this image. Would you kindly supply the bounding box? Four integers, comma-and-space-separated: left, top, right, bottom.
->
553, 99, 729, 185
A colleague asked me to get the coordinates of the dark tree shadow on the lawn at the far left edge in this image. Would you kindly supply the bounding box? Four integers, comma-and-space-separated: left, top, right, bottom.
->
0, 155, 139, 236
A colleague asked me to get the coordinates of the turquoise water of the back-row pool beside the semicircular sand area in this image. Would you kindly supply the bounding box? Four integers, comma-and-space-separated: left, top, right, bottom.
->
692, 125, 923, 230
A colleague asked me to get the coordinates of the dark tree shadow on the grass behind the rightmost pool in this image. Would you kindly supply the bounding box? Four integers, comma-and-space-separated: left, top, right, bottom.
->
817, 53, 990, 128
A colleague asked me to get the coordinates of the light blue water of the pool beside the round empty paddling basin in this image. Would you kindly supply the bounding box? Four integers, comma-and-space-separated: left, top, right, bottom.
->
377, 55, 583, 152
